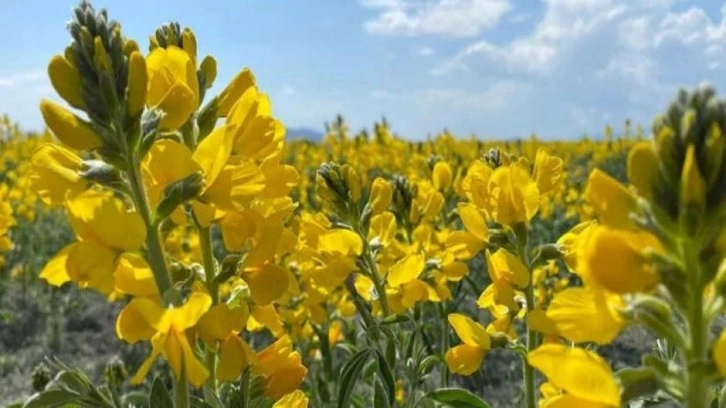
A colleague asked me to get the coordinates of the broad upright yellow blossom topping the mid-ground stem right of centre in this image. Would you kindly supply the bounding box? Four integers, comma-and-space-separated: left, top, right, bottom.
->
488, 163, 539, 226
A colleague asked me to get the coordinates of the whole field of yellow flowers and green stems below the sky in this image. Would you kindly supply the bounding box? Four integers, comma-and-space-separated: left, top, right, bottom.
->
0, 1, 726, 408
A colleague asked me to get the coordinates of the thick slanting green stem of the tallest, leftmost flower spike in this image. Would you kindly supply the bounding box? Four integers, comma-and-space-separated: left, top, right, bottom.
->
128, 162, 172, 297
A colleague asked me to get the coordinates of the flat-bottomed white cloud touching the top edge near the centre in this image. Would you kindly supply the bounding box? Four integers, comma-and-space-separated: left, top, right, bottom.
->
361, 0, 512, 37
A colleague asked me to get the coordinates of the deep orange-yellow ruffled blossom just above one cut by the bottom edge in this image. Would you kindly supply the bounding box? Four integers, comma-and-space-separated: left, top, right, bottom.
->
252, 336, 308, 400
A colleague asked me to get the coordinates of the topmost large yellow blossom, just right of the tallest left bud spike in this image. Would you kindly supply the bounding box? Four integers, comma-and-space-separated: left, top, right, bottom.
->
146, 46, 199, 131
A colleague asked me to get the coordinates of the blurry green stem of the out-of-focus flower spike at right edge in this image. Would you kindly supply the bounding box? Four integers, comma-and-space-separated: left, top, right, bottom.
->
682, 242, 709, 408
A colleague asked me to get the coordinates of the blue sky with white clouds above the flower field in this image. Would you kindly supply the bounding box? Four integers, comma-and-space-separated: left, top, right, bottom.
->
0, 0, 726, 139
